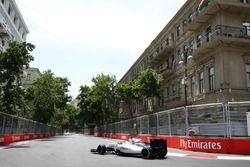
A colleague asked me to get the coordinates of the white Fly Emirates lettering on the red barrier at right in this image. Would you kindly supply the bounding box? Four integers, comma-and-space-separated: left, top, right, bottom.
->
180, 139, 222, 150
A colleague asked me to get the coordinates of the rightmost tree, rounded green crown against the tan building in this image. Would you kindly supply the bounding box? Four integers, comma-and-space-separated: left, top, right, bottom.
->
136, 68, 162, 111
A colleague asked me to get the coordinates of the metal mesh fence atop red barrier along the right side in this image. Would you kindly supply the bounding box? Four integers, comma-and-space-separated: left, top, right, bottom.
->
87, 102, 250, 138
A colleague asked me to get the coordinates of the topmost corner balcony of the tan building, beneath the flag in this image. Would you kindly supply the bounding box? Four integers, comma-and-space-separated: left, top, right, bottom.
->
187, 0, 250, 31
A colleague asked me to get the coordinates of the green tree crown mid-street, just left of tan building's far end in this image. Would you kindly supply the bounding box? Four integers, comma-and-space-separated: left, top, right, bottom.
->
77, 74, 117, 125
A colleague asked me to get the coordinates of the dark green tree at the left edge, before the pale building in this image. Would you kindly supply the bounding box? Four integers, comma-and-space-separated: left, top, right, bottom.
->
0, 41, 35, 115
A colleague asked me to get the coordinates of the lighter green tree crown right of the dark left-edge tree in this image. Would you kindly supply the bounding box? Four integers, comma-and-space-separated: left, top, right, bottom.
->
28, 70, 71, 123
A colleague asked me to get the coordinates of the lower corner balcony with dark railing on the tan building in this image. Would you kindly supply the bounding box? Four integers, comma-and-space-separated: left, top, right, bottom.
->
193, 25, 250, 58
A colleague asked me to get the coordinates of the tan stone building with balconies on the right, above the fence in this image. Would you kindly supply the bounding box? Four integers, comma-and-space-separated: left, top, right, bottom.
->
120, 0, 250, 116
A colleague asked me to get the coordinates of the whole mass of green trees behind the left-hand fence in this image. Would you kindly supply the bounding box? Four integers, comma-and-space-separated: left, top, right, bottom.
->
0, 41, 79, 128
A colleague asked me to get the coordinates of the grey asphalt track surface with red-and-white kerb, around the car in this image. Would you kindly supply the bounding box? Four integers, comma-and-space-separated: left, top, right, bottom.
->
0, 134, 250, 167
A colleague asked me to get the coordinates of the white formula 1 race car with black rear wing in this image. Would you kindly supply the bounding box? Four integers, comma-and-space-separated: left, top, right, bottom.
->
90, 138, 168, 159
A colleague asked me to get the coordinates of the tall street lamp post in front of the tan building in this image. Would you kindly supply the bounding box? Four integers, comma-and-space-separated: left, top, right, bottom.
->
179, 47, 192, 136
